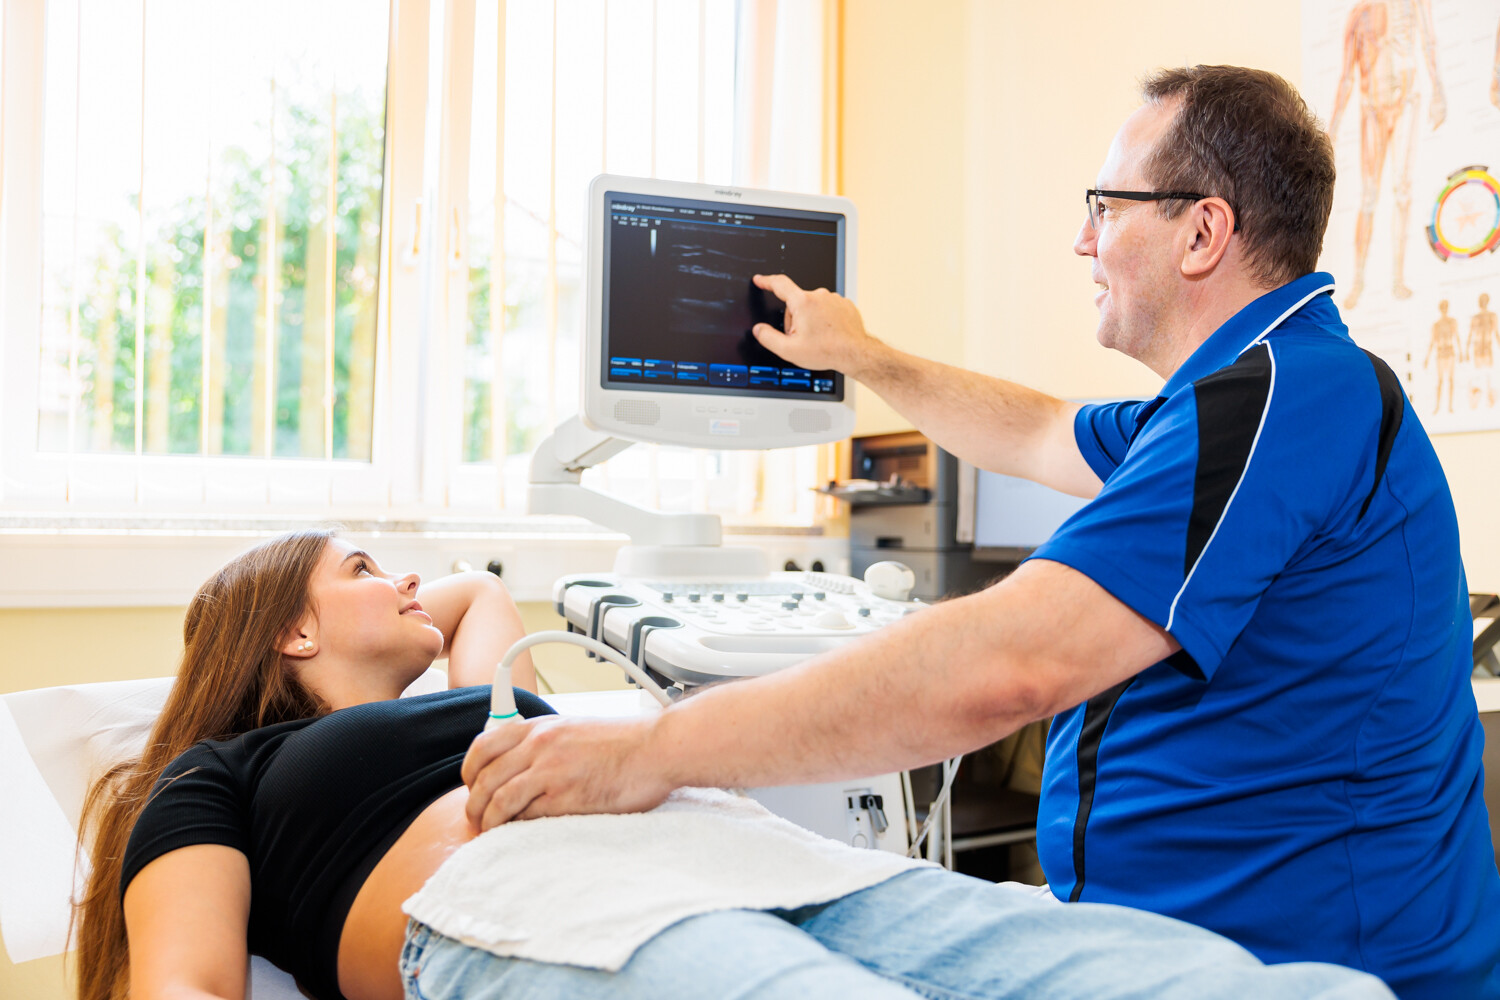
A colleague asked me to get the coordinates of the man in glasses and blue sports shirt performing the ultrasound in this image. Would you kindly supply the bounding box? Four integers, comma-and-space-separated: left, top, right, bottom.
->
465, 66, 1500, 999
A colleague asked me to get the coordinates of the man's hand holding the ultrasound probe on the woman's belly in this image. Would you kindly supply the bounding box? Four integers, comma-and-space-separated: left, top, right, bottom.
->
462, 715, 677, 832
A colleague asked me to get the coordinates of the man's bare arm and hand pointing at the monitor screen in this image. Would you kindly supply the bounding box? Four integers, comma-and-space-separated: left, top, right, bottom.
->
755, 274, 1100, 496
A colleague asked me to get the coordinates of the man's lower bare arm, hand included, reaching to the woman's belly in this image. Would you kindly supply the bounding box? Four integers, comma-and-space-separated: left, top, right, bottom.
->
464, 559, 1178, 829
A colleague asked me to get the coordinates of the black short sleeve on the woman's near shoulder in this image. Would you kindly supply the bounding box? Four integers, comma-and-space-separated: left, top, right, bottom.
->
120, 744, 249, 897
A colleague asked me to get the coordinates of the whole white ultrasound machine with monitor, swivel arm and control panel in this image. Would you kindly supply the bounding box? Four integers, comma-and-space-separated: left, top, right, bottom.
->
516, 175, 960, 850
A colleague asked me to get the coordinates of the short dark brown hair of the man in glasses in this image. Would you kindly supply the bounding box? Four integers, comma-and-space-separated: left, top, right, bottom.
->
1142, 66, 1334, 288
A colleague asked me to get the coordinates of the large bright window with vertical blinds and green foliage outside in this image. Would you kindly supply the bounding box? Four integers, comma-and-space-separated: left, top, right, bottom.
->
0, 0, 828, 523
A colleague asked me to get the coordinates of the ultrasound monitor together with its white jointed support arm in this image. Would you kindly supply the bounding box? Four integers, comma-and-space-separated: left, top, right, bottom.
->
527, 174, 857, 579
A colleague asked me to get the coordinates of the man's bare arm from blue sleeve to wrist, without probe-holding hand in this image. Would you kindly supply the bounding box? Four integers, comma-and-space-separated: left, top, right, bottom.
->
641, 561, 1178, 787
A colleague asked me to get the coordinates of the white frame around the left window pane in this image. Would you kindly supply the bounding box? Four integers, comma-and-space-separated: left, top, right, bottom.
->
0, 0, 441, 516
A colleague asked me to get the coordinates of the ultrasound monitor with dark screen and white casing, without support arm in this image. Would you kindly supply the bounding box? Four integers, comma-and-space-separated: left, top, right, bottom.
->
582, 175, 855, 448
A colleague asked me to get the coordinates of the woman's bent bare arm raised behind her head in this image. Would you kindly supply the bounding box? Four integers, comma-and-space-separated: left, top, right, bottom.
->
417, 570, 537, 691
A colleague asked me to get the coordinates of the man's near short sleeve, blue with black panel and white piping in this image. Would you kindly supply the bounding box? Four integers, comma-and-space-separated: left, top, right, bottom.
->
1034, 346, 1340, 679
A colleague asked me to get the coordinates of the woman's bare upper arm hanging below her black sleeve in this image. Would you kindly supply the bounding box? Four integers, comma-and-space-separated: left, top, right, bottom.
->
125, 844, 251, 1000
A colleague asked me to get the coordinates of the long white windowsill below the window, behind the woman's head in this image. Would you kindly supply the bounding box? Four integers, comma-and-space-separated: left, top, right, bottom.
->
0, 513, 848, 609
